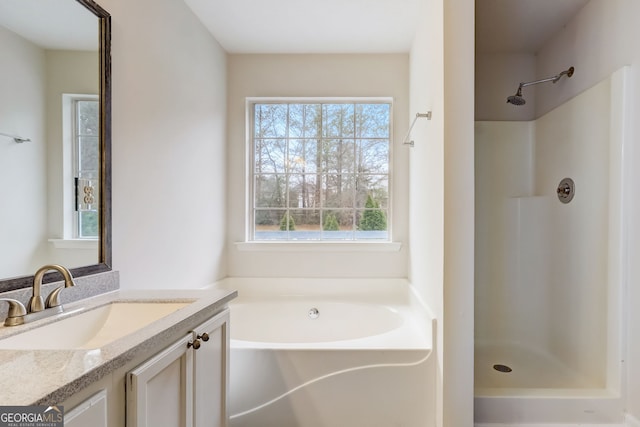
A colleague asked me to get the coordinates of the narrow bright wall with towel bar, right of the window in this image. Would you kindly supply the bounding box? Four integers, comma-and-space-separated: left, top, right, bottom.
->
409, 2, 444, 426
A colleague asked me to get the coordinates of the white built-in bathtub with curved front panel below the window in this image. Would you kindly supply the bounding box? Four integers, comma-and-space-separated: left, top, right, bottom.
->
218, 279, 435, 427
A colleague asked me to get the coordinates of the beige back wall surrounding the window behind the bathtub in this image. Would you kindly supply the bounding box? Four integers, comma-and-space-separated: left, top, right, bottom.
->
227, 54, 409, 277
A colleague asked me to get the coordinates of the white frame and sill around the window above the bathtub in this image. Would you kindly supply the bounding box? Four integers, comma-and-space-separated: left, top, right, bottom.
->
245, 97, 401, 244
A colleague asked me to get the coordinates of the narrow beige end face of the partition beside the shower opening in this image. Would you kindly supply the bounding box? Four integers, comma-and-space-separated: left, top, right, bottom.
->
442, 0, 475, 427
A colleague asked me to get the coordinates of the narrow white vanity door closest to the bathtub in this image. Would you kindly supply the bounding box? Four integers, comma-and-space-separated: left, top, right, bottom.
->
193, 309, 229, 427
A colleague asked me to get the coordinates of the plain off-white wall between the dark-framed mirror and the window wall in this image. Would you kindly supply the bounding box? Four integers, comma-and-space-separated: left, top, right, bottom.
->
100, 0, 227, 289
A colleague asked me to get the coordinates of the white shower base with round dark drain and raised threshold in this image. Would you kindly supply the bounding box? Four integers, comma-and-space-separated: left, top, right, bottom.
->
474, 342, 623, 424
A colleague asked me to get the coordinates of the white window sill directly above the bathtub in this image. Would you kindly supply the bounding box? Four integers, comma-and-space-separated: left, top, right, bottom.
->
235, 241, 402, 252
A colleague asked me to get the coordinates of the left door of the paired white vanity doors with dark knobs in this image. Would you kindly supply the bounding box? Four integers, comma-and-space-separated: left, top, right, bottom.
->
126, 334, 193, 427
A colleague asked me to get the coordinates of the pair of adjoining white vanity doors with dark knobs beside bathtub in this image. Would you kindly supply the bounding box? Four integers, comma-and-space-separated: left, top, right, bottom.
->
125, 309, 229, 427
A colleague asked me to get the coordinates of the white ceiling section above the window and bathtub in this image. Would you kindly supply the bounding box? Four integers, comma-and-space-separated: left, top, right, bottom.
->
185, 0, 423, 53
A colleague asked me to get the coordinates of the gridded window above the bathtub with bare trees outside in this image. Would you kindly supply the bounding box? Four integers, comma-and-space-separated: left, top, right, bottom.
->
249, 99, 391, 241
